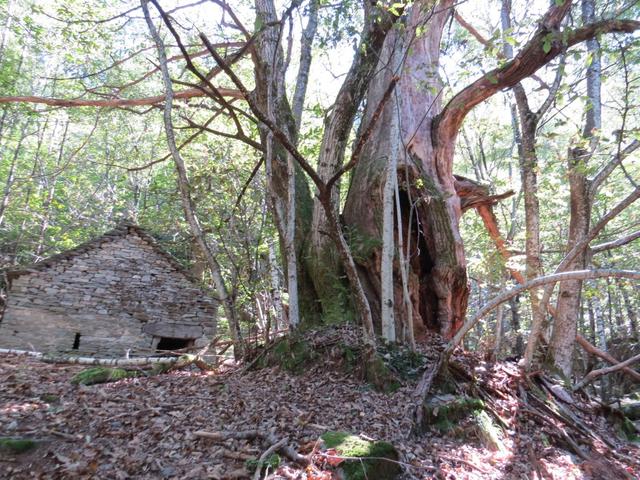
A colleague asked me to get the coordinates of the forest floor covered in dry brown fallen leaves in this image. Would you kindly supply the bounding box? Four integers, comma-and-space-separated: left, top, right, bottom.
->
0, 328, 640, 480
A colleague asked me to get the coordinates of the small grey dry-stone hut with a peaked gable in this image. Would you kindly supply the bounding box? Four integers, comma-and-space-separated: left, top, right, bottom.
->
0, 222, 218, 356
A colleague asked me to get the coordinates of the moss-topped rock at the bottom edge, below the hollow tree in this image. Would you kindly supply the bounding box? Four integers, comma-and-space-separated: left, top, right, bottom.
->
320, 432, 402, 480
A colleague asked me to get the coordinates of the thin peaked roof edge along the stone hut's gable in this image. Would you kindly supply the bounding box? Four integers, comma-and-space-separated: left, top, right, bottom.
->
5, 220, 197, 283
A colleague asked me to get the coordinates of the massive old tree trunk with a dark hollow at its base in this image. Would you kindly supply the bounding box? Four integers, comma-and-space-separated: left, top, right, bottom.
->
343, 1, 468, 340
